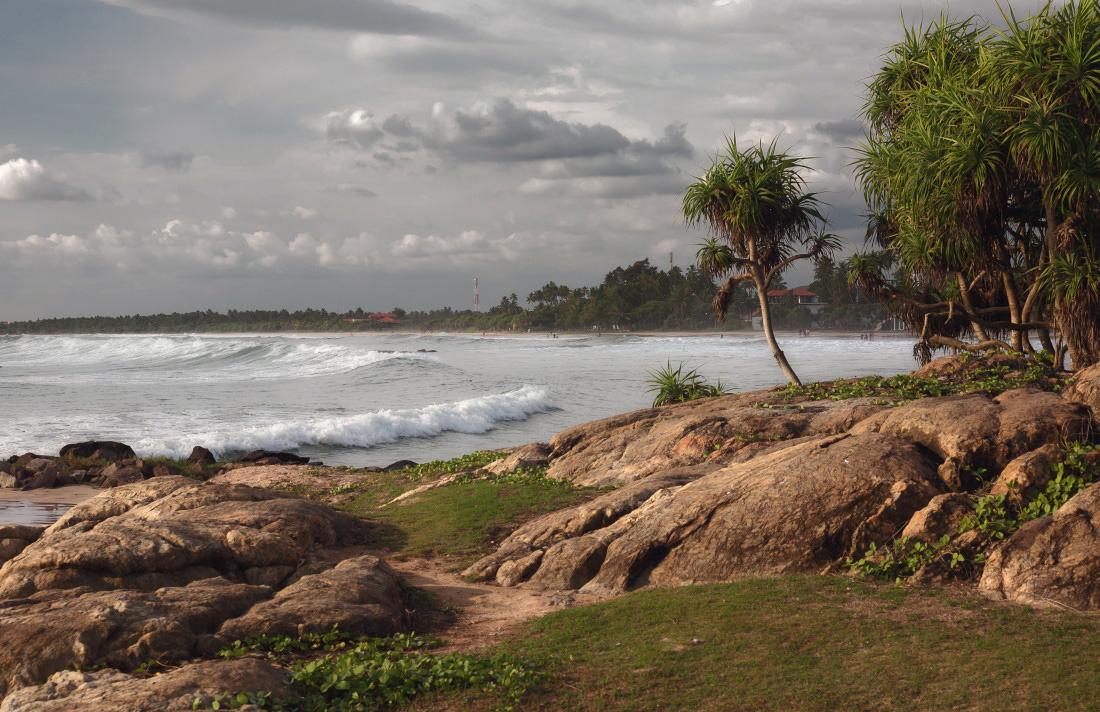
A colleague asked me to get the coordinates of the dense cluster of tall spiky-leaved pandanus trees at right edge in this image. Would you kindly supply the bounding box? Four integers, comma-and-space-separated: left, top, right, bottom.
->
849, 5, 1100, 370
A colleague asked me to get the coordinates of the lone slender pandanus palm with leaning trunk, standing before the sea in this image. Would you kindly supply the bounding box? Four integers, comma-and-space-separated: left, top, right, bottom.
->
681, 136, 839, 384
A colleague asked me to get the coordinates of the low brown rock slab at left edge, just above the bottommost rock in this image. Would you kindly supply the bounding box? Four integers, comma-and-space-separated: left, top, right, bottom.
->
0, 579, 271, 694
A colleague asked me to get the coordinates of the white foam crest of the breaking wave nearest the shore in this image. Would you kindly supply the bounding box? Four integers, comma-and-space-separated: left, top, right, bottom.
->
132, 385, 557, 458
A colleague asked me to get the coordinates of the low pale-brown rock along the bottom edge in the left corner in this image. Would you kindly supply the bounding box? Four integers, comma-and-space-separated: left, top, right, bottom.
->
0, 657, 293, 712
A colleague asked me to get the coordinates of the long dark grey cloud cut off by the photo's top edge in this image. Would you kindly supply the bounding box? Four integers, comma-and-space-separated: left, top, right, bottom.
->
101, 0, 472, 35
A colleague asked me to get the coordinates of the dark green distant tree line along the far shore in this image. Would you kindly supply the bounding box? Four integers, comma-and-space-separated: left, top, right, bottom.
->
0, 259, 883, 333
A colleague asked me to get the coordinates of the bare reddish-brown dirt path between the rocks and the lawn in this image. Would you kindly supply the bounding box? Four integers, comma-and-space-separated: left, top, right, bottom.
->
389, 559, 607, 653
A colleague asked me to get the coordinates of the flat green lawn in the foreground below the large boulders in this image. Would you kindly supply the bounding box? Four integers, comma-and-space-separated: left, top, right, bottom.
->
403, 577, 1100, 711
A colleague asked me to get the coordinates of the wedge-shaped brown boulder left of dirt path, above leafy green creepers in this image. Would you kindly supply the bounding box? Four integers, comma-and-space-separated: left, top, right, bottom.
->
218, 556, 408, 642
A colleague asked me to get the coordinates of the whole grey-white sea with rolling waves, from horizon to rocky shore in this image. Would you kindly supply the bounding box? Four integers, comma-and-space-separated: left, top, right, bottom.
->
0, 333, 916, 467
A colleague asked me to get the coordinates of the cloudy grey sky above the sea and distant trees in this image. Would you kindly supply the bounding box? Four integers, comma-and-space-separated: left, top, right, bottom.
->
0, 0, 1007, 320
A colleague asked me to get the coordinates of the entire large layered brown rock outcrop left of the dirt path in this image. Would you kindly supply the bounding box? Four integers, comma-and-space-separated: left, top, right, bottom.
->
0, 477, 407, 704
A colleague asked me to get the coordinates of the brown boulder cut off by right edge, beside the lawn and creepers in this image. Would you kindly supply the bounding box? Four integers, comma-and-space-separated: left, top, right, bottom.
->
978, 484, 1100, 611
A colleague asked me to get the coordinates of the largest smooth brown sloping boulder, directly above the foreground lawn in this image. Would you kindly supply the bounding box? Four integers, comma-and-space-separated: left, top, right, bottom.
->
466, 434, 938, 593
